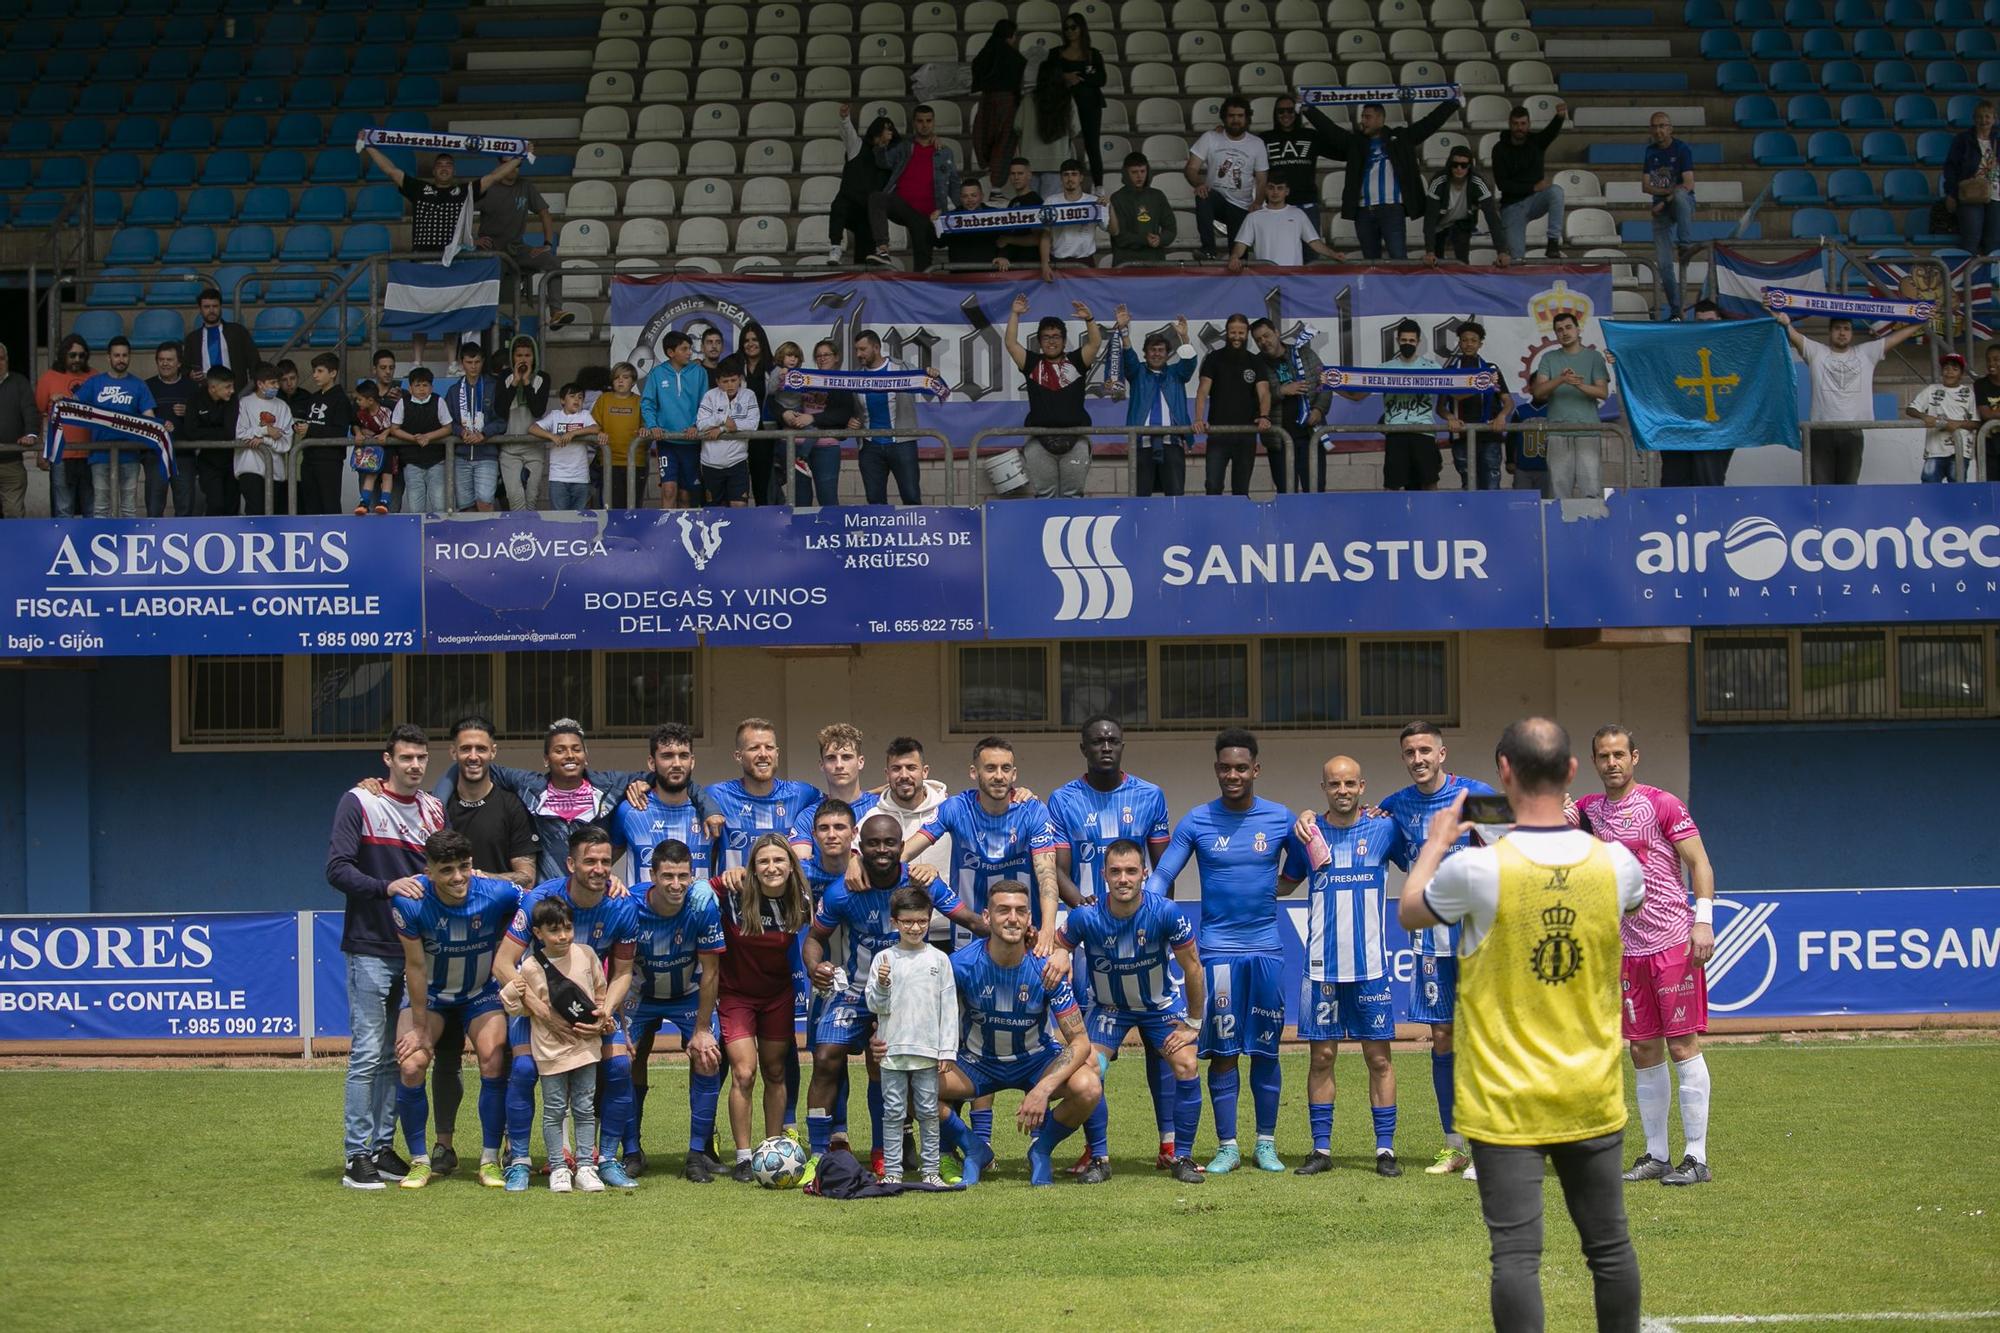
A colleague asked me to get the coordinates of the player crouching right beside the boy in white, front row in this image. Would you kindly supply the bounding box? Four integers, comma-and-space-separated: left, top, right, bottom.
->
938, 879, 1104, 1185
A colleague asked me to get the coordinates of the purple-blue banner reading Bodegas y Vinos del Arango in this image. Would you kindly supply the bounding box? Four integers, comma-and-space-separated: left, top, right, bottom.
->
424, 506, 984, 652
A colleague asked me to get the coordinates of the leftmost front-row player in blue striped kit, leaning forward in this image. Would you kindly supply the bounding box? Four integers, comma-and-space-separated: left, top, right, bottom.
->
394, 829, 520, 1189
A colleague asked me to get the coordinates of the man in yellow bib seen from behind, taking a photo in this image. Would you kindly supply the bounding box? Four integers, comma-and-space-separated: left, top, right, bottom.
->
1398, 717, 1646, 1333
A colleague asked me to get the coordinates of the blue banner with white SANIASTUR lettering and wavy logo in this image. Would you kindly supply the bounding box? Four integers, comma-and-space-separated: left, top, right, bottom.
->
986, 492, 1542, 638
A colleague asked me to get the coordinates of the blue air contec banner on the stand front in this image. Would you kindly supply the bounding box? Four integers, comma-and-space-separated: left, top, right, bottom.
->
1542, 486, 2000, 626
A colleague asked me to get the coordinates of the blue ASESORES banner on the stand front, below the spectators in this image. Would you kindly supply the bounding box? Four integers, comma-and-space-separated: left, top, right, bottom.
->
0, 514, 422, 656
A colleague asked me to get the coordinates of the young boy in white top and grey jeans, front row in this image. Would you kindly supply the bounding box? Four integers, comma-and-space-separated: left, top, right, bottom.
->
868, 885, 958, 1185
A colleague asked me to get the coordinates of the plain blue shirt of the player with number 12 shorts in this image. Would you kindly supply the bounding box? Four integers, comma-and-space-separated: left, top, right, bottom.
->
1146, 797, 1306, 957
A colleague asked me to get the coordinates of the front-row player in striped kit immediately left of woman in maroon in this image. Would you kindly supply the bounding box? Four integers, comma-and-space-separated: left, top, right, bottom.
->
620, 839, 724, 1185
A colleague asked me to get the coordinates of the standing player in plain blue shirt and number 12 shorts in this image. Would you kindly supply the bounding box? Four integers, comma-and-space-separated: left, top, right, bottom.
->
1146, 727, 1304, 1175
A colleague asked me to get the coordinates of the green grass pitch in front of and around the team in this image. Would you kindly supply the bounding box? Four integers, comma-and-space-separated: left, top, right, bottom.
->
0, 1039, 2000, 1333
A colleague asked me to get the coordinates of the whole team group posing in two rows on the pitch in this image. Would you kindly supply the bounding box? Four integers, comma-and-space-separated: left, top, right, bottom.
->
326, 717, 1714, 1191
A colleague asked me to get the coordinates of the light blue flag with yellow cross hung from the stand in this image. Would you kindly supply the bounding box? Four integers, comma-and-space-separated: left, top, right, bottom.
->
1604, 318, 1798, 448
